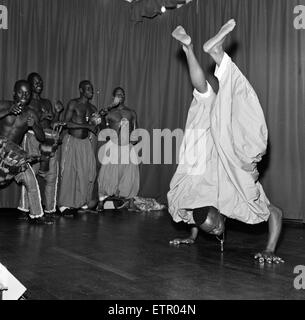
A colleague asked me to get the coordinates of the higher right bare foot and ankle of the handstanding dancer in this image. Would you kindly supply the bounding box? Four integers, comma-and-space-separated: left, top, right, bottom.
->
203, 19, 236, 65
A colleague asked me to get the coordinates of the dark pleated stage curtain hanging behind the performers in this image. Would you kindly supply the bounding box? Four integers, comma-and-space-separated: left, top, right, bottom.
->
0, 0, 305, 219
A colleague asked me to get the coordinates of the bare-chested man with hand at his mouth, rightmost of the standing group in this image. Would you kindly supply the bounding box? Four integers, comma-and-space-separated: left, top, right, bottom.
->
98, 87, 140, 209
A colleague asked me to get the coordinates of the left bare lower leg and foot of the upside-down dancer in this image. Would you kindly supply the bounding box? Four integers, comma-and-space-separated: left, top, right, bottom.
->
172, 26, 208, 93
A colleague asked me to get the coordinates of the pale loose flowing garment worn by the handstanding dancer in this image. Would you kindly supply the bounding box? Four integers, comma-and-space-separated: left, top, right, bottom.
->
167, 54, 270, 224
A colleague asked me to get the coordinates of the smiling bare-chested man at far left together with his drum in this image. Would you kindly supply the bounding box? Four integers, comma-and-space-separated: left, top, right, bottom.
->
0, 80, 50, 223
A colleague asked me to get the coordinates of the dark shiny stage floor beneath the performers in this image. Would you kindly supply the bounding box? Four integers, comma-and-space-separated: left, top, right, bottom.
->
0, 209, 305, 300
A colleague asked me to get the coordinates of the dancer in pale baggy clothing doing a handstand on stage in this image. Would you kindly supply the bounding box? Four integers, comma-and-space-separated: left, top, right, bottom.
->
168, 19, 283, 263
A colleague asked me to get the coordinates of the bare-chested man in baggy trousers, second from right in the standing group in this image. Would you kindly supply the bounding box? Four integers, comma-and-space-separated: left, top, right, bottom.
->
58, 80, 97, 215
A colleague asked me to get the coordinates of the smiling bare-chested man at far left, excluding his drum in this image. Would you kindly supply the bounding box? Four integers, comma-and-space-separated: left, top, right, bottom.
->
0, 80, 48, 223
